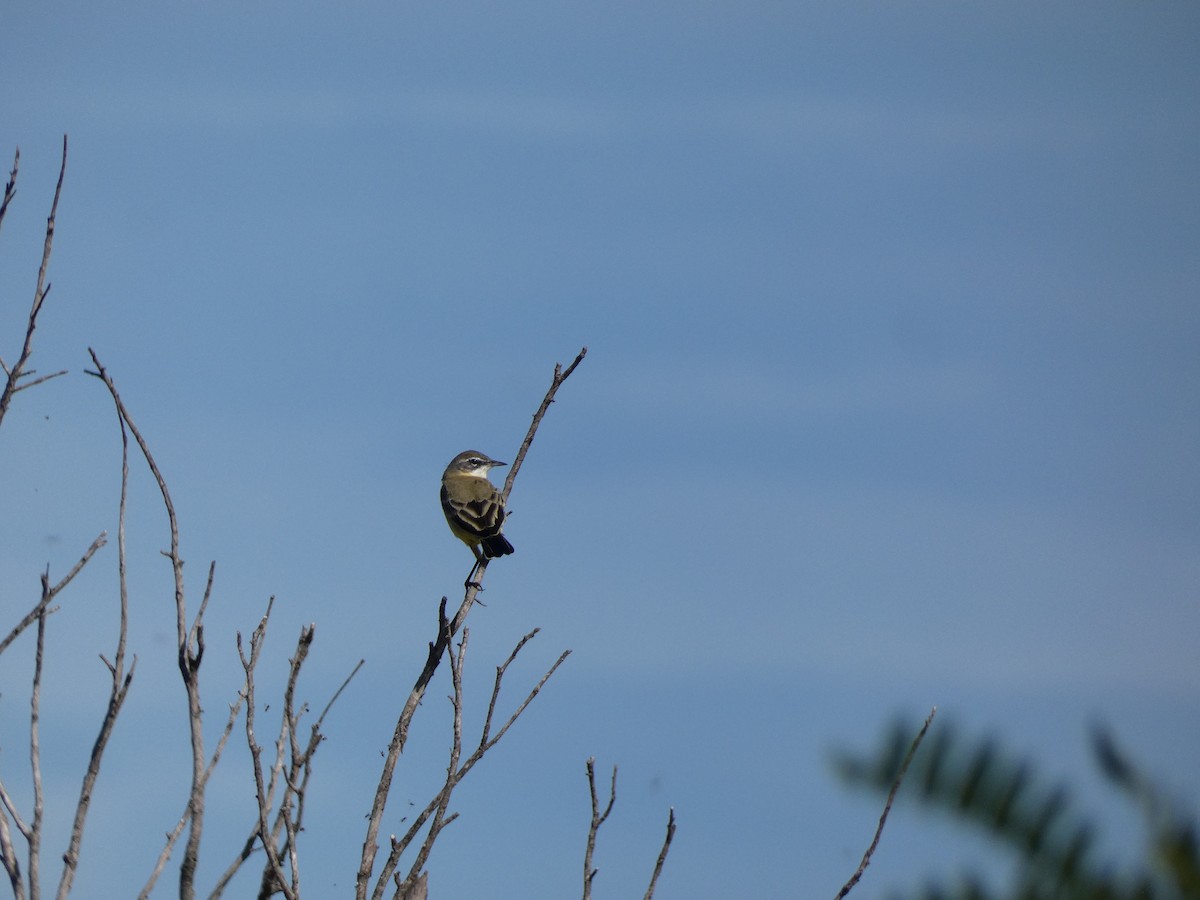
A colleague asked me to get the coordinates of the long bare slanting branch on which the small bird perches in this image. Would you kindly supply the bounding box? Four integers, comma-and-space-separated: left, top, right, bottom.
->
355, 347, 587, 900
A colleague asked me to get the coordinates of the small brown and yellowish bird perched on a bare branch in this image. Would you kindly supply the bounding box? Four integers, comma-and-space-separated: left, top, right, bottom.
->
442, 450, 512, 586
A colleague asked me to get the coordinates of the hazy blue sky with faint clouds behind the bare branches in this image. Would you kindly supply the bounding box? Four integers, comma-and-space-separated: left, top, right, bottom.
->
0, 2, 1200, 898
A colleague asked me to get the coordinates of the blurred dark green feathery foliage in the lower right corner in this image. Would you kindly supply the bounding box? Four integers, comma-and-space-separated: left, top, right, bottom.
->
838, 724, 1200, 900
